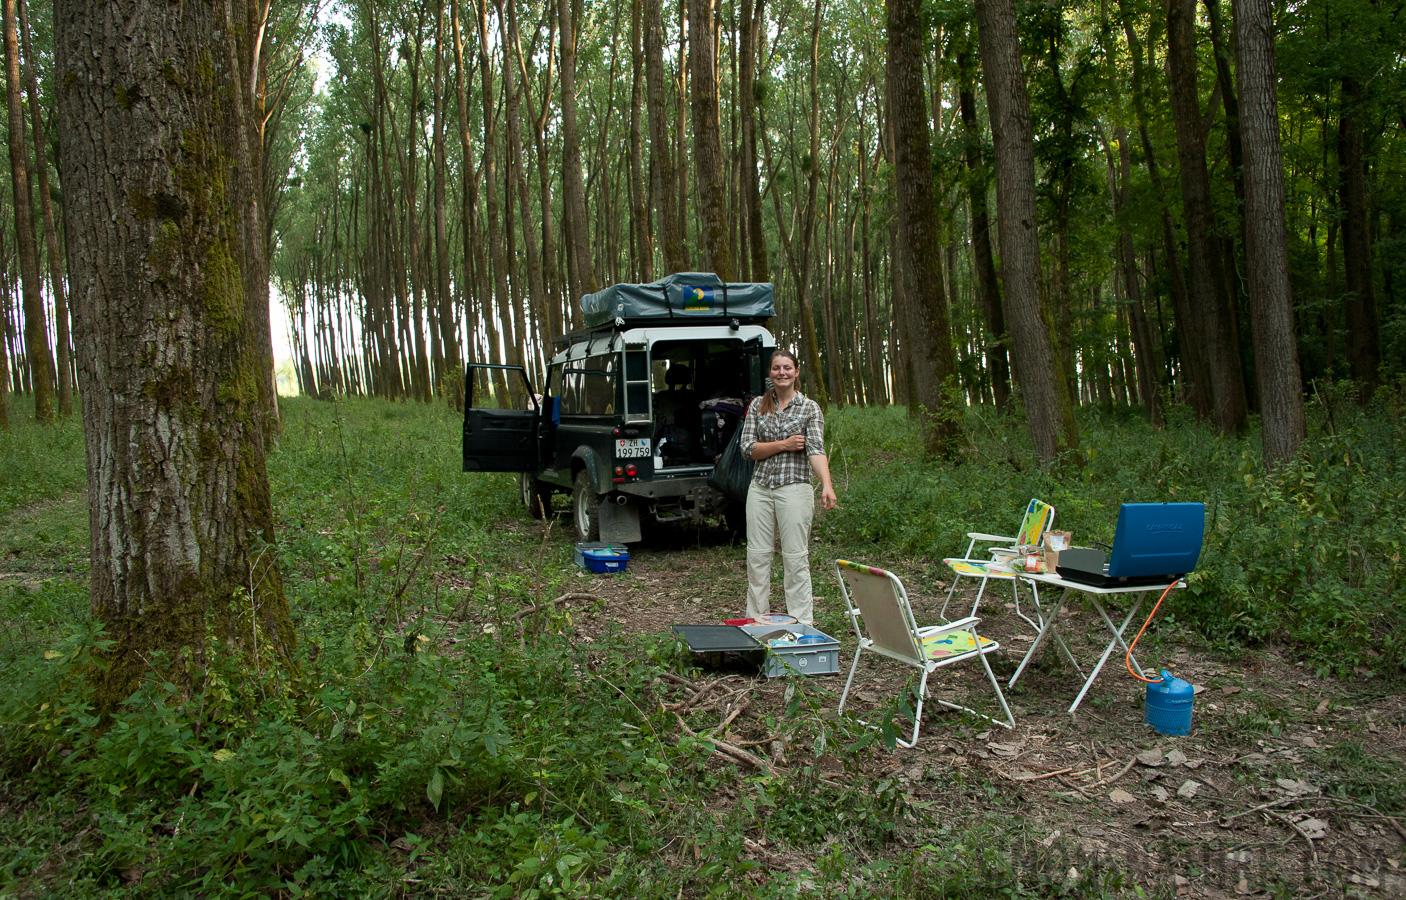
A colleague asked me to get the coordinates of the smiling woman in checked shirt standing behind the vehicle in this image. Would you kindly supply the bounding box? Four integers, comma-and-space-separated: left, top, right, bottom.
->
741, 350, 835, 624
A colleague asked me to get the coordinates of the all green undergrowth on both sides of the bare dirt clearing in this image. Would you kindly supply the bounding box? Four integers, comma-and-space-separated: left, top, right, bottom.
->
0, 391, 1406, 899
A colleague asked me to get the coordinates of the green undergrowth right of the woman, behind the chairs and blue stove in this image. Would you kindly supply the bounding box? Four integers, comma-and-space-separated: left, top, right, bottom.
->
821, 381, 1406, 675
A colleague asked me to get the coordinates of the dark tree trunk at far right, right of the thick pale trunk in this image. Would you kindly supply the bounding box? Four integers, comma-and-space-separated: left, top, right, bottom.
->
1338, 76, 1382, 399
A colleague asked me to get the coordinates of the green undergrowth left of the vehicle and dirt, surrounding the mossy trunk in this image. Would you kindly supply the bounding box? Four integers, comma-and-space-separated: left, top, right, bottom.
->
0, 401, 1137, 899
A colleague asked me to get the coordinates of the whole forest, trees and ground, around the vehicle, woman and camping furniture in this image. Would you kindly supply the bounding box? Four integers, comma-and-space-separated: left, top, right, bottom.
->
0, 0, 1406, 900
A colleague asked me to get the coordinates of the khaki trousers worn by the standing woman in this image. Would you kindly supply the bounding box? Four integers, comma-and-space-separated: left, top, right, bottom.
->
747, 481, 815, 624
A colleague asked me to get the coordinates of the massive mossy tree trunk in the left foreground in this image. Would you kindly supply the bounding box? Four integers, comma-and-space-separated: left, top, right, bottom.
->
55, 0, 294, 709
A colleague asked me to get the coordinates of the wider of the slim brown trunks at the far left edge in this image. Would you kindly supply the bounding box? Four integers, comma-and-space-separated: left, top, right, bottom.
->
4, 0, 53, 422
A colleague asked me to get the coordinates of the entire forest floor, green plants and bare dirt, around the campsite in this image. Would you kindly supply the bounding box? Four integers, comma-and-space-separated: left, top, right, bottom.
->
0, 397, 1406, 897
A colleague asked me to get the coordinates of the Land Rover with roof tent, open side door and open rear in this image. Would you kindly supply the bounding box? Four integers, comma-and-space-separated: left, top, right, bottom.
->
464, 273, 776, 543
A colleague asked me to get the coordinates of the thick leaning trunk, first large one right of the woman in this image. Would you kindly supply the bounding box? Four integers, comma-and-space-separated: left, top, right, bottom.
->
887, 0, 962, 458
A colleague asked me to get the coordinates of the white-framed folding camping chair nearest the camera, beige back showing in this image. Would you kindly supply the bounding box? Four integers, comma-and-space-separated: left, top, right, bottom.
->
835, 560, 1015, 748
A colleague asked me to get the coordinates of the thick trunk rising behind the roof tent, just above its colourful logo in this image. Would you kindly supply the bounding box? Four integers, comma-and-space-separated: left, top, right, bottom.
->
689, 0, 733, 281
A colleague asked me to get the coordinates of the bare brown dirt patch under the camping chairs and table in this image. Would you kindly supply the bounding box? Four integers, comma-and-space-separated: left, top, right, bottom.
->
528, 520, 1406, 897
